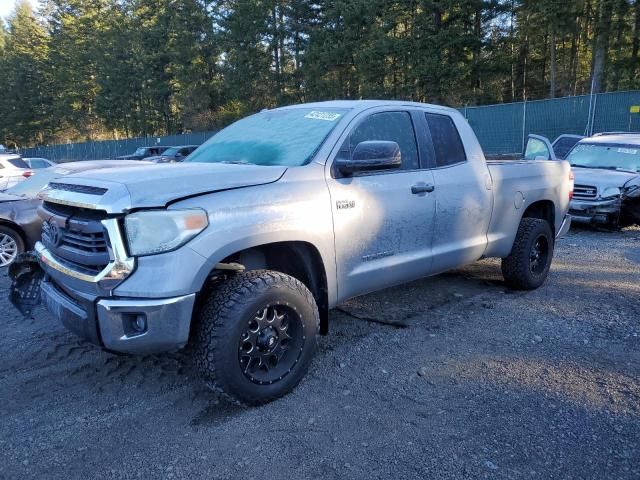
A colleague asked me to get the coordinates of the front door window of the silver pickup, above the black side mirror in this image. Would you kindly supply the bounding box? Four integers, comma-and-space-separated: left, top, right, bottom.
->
338, 111, 420, 170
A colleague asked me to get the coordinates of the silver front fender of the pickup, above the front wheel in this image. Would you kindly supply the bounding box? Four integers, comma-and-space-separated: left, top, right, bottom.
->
114, 164, 337, 304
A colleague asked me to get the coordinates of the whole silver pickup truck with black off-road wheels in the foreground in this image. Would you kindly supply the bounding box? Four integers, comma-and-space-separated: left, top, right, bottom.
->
18, 101, 573, 404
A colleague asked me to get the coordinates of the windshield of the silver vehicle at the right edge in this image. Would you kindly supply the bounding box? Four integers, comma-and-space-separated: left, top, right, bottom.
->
567, 143, 640, 172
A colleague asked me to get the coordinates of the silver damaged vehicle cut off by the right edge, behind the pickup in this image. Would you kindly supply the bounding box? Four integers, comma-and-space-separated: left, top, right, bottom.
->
567, 133, 640, 228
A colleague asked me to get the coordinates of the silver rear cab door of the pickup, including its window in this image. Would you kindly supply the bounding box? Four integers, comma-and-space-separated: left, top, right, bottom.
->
422, 111, 493, 272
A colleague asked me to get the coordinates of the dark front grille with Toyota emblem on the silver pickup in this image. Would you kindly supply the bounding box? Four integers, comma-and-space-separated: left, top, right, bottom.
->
42, 206, 111, 273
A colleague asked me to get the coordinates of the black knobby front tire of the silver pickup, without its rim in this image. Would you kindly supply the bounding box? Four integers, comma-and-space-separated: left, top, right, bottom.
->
192, 270, 320, 405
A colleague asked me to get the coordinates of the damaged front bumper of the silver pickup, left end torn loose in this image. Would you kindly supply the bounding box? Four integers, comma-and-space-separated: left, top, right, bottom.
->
9, 245, 196, 354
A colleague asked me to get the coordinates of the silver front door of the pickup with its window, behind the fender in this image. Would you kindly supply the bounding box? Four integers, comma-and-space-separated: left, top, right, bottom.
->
327, 108, 435, 300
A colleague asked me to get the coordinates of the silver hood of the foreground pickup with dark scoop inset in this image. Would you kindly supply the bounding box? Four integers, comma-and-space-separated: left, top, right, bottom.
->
40, 162, 287, 213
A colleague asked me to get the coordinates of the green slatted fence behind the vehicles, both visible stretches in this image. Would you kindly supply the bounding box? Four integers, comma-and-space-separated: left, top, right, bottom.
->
21, 90, 640, 162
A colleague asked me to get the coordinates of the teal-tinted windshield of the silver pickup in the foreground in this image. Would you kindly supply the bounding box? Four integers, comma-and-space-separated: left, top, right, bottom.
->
185, 108, 346, 167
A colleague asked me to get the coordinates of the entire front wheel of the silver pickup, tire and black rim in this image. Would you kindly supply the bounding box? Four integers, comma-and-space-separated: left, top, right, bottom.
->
194, 270, 320, 405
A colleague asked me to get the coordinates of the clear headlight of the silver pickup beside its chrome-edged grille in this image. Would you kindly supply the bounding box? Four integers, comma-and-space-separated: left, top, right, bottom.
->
124, 209, 209, 256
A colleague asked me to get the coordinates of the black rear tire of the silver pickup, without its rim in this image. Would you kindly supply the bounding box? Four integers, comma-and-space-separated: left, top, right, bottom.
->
502, 218, 554, 290
